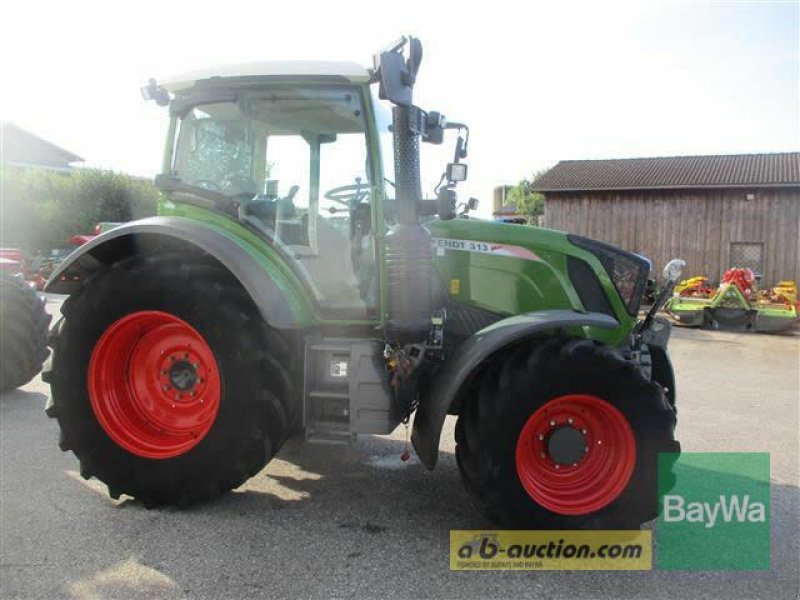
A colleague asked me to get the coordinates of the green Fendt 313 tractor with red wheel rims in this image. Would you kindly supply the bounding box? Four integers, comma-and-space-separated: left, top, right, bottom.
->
44, 38, 679, 528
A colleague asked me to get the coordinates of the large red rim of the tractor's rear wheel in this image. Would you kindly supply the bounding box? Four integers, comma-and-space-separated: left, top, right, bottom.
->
88, 311, 220, 458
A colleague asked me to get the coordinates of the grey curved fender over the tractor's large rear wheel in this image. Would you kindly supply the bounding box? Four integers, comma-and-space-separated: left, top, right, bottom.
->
45, 217, 313, 328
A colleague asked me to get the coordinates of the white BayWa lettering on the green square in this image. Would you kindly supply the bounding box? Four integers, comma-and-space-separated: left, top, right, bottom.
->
664, 494, 767, 529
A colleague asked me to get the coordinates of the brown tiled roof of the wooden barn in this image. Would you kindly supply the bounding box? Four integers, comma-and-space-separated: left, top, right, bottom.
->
533, 152, 800, 192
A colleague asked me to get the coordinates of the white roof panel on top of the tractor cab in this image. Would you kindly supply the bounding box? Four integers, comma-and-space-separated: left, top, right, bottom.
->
165, 61, 370, 92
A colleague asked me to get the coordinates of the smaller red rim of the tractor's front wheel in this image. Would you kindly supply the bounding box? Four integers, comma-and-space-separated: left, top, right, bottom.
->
516, 394, 636, 515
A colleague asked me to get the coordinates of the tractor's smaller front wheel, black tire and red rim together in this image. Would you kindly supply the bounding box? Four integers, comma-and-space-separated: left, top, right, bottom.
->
456, 339, 679, 529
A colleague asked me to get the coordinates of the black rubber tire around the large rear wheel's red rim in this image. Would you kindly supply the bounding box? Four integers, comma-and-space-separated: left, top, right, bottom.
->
46, 258, 294, 508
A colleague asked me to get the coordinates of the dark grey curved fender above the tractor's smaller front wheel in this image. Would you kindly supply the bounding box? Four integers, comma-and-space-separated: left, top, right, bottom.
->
411, 310, 619, 469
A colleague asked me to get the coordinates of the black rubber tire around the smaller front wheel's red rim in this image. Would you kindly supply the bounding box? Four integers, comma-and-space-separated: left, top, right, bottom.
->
456, 339, 680, 529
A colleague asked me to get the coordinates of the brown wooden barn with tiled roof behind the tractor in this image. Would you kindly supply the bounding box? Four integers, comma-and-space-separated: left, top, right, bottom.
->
533, 152, 800, 287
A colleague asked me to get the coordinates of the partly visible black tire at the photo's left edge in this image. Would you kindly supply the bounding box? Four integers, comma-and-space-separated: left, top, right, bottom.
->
0, 273, 51, 392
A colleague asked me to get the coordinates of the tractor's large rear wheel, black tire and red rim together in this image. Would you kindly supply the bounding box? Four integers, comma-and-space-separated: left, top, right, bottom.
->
47, 259, 292, 507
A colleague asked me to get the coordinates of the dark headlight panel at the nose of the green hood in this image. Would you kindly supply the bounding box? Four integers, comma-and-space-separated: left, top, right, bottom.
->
567, 234, 651, 317
